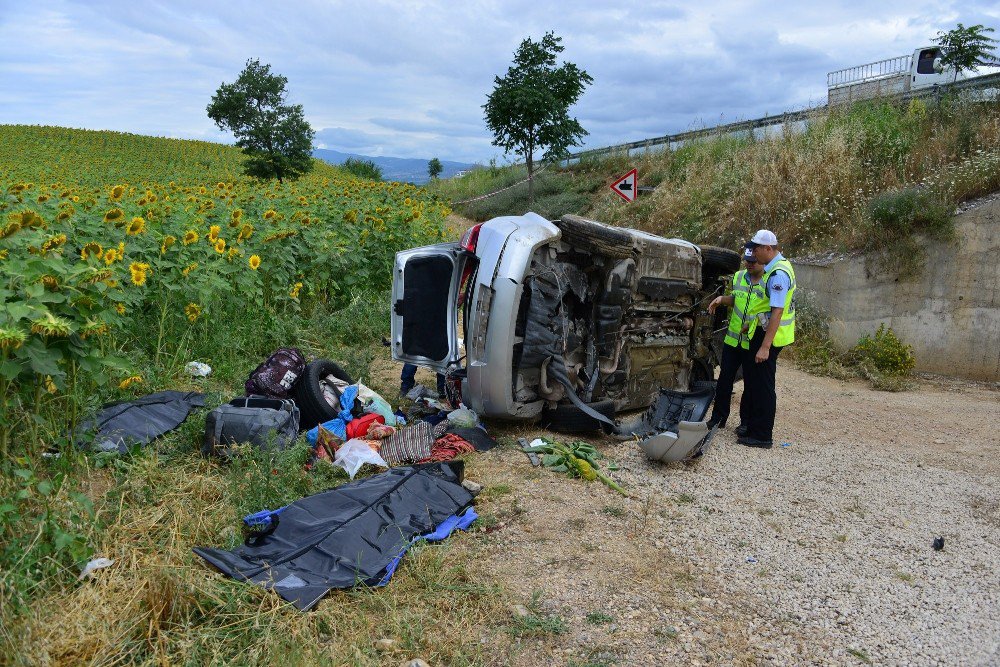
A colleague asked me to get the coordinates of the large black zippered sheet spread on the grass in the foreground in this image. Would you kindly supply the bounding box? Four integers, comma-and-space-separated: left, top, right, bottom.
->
194, 461, 472, 611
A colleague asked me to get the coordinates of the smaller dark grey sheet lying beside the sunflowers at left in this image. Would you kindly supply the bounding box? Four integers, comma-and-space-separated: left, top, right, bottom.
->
76, 391, 205, 454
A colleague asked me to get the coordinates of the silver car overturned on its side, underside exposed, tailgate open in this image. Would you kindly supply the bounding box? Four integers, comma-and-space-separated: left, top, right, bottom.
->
392, 213, 740, 460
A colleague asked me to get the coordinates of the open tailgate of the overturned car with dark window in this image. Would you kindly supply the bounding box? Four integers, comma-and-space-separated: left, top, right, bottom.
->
392, 243, 469, 373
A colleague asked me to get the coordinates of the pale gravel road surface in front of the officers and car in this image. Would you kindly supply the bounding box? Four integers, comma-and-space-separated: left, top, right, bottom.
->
470, 364, 1000, 665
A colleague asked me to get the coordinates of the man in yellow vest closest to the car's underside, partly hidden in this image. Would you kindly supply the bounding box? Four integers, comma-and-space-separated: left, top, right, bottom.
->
708, 246, 764, 435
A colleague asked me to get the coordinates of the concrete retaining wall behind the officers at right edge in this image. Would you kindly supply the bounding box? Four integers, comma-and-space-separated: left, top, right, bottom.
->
792, 199, 1000, 381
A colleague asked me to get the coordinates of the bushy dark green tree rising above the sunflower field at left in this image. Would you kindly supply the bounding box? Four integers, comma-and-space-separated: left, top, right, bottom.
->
207, 59, 316, 181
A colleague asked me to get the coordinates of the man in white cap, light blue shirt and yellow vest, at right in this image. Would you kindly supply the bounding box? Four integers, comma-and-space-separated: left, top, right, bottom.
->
737, 229, 795, 449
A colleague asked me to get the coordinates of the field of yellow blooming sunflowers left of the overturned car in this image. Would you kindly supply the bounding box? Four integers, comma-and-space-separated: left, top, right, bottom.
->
0, 125, 449, 456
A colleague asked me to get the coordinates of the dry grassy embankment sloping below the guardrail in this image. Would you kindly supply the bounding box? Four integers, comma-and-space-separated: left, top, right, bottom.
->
435, 98, 1000, 258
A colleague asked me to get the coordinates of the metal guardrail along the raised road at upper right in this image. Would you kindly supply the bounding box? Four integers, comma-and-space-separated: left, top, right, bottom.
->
561, 71, 1000, 163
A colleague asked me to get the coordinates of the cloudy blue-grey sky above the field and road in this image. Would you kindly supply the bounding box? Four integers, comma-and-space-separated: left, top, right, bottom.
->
0, 0, 1000, 163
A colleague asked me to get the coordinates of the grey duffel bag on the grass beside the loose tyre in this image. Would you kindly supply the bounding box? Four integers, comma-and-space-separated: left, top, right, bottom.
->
201, 396, 299, 458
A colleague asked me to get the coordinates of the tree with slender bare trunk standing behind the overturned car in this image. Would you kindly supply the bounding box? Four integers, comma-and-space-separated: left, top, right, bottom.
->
483, 32, 594, 204
